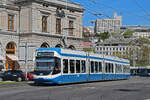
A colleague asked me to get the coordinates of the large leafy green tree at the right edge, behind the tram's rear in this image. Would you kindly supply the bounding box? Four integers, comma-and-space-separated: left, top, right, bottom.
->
128, 38, 150, 66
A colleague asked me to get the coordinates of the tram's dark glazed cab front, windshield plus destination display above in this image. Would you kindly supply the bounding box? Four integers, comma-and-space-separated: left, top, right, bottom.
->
35, 52, 61, 76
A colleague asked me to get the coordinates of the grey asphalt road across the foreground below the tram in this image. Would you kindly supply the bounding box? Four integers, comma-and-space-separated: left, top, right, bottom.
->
0, 77, 150, 100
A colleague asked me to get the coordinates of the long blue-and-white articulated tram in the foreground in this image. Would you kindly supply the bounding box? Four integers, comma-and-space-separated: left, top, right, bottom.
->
34, 48, 130, 84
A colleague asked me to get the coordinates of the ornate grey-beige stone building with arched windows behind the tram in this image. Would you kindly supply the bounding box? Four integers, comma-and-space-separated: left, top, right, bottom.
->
0, 0, 84, 70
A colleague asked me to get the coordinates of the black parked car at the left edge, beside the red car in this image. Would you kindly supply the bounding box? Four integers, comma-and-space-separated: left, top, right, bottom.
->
0, 70, 25, 82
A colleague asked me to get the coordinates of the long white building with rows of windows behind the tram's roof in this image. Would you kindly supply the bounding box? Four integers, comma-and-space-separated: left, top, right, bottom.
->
95, 36, 131, 56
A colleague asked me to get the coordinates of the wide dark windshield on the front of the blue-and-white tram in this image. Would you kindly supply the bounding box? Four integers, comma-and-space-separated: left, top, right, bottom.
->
35, 57, 61, 75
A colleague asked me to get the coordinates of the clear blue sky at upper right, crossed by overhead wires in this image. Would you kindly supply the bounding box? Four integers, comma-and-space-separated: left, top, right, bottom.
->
70, 0, 150, 26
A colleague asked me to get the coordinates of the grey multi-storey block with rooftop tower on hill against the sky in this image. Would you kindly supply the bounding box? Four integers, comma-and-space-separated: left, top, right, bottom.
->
95, 13, 122, 33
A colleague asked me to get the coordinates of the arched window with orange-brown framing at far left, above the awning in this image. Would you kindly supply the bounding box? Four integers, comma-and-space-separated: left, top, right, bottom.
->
6, 42, 16, 55
